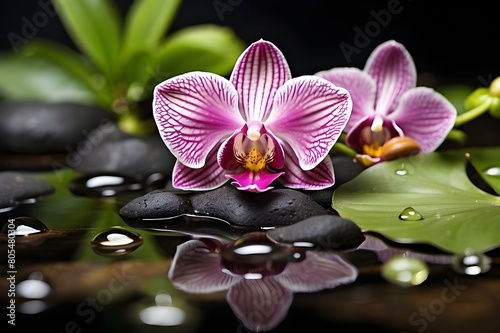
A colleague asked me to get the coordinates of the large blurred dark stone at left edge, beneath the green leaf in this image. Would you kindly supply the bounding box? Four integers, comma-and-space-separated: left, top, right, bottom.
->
0, 101, 115, 154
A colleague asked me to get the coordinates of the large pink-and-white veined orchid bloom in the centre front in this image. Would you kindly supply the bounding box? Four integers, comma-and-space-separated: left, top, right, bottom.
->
153, 40, 352, 192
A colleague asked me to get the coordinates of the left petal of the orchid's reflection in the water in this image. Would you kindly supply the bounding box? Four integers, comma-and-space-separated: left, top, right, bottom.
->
168, 240, 241, 293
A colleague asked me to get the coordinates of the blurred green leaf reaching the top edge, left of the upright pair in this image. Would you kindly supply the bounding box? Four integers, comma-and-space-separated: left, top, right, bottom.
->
53, 0, 121, 81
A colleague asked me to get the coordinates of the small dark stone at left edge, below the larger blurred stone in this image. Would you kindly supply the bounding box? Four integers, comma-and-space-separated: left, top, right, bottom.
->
0, 171, 54, 213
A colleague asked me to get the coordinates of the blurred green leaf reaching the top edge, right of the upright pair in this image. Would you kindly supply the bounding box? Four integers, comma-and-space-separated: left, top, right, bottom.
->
121, 0, 180, 64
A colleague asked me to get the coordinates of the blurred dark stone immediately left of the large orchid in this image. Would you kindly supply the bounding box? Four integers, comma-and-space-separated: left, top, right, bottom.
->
68, 125, 175, 179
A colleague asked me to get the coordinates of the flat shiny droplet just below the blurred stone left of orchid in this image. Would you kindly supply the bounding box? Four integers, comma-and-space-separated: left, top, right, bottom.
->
68, 174, 144, 197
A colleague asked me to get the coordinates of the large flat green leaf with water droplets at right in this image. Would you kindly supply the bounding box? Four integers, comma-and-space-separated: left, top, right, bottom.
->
332, 147, 500, 254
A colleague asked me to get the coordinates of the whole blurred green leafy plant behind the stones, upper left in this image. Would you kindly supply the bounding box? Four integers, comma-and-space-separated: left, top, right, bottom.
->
0, 0, 246, 134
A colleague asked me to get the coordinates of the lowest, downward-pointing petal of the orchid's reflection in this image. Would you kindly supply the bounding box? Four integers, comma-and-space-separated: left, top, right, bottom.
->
226, 277, 293, 332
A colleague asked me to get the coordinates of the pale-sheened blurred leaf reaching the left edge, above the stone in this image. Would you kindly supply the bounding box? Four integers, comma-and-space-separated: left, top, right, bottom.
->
0, 53, 103, 105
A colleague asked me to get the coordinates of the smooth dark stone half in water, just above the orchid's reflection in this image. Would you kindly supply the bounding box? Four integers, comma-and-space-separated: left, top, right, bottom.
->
267, 214, 365, 250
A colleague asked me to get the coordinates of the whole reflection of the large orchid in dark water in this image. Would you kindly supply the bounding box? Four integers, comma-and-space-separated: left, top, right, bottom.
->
169, 237, 358, 331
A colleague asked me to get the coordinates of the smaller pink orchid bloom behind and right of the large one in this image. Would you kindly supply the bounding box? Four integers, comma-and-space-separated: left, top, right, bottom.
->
316, 40, 457, 165
